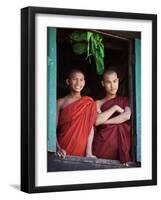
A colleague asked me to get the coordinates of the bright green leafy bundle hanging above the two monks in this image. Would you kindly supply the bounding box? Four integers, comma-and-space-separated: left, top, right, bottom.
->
69, 31, 104, 75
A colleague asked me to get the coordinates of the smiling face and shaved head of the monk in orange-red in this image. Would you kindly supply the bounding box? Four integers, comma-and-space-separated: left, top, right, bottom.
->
66, 72, 85, 92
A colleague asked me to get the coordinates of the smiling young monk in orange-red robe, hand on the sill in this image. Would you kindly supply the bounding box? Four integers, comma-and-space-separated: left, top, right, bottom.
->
57, 69, 96, 157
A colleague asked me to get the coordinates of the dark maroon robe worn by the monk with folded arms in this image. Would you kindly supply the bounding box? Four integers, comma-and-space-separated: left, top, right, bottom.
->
93, 96, 130, 163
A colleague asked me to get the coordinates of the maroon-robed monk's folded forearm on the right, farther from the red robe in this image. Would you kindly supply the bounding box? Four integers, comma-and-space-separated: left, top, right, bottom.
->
104, 107, 131, 124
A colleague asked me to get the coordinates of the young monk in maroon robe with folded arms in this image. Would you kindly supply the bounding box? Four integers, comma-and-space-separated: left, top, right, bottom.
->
93, 70, 131, 166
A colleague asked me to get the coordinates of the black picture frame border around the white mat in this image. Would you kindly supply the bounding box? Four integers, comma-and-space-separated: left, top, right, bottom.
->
21, 7, 157, 193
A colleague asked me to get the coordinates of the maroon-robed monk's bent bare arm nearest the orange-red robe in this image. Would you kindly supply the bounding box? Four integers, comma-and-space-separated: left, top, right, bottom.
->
95, 102, 124, 126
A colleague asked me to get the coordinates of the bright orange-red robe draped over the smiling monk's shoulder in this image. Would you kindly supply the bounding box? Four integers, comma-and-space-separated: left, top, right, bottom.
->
58, 96, 96, 156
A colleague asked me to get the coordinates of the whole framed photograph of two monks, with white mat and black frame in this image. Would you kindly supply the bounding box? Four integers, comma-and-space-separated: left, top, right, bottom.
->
21, 7, 157, 193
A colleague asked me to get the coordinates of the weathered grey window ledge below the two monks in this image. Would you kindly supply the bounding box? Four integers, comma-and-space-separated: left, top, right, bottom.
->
48, 153, 140, 172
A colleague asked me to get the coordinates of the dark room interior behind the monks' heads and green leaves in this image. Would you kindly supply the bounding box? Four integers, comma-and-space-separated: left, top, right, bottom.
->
57, 28, 131, 99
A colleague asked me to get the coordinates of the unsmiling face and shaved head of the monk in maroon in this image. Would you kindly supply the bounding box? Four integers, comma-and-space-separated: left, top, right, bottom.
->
102, 72, 119, 95
